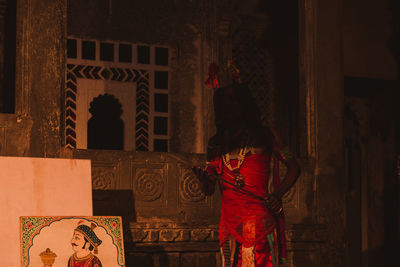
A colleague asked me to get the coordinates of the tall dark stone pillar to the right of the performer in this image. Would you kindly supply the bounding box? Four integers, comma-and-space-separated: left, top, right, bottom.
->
295, 0, 346, 266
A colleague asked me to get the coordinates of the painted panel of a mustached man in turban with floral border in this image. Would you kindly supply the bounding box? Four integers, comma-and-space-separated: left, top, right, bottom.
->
20, 216, 125, 267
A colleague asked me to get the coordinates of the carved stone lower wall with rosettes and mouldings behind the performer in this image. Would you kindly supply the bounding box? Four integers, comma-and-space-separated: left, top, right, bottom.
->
71, 150, 327, 267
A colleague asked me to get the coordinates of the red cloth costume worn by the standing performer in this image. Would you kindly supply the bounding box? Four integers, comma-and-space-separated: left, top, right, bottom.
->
207, 152, 278, 267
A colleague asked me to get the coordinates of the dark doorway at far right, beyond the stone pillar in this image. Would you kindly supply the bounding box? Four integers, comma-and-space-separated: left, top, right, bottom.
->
344, 77, 400, 267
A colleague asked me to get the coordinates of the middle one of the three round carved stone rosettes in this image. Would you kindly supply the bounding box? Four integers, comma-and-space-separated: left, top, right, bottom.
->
135, 169, 164, 202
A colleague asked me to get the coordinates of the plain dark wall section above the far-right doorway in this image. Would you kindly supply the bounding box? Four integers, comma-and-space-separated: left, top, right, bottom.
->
342, 0, 398, 80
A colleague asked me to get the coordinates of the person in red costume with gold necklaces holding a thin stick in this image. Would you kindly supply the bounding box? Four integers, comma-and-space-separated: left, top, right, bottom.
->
193, 78, 300, 267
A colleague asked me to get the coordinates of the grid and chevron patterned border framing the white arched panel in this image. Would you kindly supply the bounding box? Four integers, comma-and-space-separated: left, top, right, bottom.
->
65, 37, 170, 152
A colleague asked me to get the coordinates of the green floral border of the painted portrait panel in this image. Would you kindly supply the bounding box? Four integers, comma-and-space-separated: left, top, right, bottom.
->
20, 216, 125, 267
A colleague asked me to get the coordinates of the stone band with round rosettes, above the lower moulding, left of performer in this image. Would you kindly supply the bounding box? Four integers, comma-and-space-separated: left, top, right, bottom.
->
73, 150, 220, 224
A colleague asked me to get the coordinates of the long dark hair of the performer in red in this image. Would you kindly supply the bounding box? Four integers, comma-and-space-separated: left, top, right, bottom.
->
207, 83, 273, 160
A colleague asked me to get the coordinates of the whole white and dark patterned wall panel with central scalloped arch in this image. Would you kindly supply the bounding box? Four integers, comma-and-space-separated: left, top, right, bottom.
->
65, 37, 170, 152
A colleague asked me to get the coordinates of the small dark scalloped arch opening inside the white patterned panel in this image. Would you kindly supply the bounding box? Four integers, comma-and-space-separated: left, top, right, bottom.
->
87, 94, 124, 150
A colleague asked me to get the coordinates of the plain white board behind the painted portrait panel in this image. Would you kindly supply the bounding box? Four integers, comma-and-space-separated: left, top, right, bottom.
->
0, 157, 93, 267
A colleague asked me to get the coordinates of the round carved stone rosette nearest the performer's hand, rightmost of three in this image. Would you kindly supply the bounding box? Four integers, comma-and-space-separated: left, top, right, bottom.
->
179, 171, 206, 202
